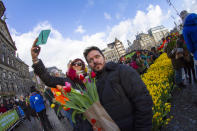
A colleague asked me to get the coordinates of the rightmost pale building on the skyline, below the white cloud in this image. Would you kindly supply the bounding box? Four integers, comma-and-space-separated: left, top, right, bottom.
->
148, 25, 169, 44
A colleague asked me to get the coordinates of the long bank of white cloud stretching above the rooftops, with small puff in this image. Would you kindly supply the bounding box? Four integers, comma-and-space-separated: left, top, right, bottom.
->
10, 5, 172, 72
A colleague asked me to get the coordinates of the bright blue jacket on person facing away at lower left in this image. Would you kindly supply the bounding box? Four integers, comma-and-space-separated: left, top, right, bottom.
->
29, 92, 45, 112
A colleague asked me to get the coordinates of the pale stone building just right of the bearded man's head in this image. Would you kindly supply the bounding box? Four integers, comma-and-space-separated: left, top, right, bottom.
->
102, 38, 126, 62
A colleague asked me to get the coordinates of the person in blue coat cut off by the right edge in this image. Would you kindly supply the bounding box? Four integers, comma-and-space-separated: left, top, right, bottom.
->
180, 10, 197, 76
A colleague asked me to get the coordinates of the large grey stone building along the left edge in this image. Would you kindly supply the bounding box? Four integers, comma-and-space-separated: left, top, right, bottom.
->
0, 1, 33, 95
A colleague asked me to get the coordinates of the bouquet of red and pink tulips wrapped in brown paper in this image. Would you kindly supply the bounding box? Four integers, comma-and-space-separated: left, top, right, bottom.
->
52, 72, 120, 131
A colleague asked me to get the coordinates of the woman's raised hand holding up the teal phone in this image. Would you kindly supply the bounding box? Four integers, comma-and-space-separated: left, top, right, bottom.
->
31, 38, 41, 62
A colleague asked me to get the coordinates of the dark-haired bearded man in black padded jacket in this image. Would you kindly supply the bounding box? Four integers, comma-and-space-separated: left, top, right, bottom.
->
84, 46, 153, 131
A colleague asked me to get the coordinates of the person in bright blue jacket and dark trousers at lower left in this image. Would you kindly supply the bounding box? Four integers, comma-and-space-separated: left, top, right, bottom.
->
29, 86, 52, 131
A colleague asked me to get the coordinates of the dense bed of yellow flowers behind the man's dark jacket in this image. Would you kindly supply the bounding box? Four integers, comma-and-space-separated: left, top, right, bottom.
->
141, 53, 174, 130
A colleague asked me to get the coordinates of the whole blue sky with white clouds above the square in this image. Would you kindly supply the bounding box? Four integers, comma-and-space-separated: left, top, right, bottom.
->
3, 0, 197, 73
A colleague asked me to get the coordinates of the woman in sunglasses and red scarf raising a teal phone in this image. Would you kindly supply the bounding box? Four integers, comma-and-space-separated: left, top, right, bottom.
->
31, 38, 93, 131
